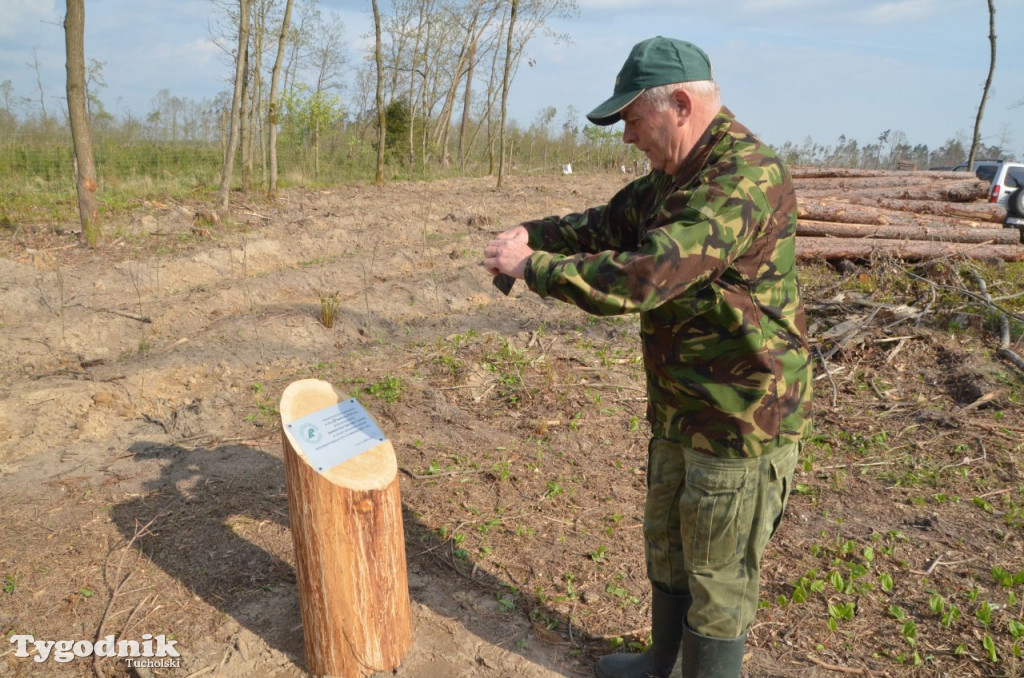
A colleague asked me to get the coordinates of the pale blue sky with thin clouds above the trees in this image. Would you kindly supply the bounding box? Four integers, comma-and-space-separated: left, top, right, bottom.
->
0, 0, 1024, 159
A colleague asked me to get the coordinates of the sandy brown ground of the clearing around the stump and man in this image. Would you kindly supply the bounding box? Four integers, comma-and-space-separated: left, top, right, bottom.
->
0, 174, 1024, 678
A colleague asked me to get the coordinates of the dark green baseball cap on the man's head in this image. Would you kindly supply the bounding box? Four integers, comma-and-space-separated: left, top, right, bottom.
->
587, 36, 713, 125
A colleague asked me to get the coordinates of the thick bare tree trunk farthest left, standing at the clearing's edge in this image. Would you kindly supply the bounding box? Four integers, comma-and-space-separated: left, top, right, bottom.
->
65, 0, 102, 247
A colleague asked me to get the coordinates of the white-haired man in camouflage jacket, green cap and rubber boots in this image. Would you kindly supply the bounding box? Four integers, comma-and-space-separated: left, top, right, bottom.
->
483, 37, 811, 678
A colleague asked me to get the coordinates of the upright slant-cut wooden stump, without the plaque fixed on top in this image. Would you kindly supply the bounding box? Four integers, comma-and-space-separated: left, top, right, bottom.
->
281, 379, 413, 678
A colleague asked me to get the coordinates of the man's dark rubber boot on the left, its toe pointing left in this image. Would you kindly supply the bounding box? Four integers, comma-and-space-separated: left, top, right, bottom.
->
597, 586, 693, 678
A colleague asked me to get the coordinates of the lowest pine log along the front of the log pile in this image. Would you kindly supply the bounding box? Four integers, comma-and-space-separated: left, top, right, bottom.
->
797, 238, 1024, 261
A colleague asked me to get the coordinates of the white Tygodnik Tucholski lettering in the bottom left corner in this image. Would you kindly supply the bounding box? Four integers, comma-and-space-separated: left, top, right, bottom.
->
10, 633, 181, 669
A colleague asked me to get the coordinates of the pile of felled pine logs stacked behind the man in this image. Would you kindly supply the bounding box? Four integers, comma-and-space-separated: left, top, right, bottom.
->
793, 168, 1024, 261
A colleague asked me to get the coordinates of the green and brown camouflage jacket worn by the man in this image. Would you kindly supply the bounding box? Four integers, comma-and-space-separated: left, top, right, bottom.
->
522, 108, 811, 457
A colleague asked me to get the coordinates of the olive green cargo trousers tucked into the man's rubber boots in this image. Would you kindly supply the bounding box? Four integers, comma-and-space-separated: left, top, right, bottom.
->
643, 438, 800, 638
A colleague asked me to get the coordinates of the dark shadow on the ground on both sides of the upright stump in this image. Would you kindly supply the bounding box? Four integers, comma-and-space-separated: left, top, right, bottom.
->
111, 442, 581, 675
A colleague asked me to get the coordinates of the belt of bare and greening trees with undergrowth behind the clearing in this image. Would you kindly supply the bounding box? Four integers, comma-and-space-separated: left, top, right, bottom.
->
0, 0, 1016, 225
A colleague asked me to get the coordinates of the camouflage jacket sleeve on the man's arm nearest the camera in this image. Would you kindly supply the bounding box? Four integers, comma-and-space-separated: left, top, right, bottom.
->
525, 167, 773, 315
